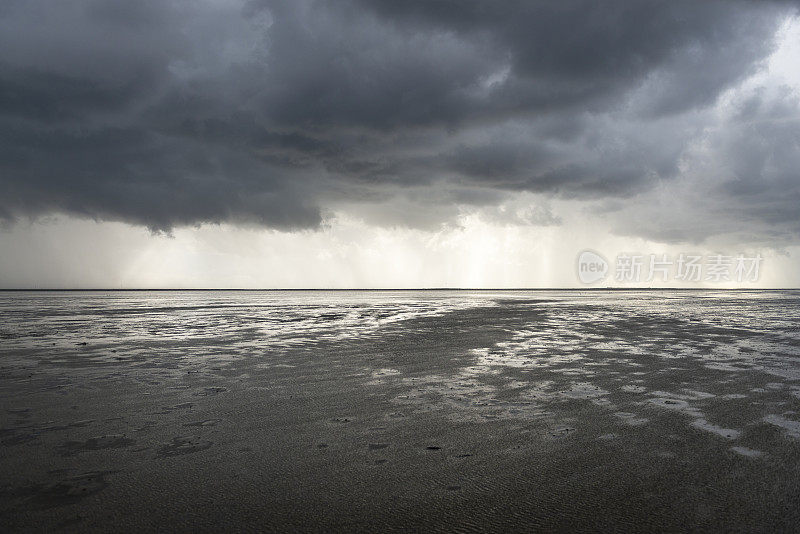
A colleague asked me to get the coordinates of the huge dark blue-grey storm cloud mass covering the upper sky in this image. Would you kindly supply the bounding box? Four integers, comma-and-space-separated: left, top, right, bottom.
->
0, 0, 797, 237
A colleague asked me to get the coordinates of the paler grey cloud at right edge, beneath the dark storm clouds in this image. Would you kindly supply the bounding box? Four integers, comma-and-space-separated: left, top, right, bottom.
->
605, 86, 800, 247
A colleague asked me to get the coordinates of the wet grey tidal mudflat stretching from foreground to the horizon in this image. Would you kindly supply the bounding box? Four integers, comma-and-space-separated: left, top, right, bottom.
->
0, 291, 800, 532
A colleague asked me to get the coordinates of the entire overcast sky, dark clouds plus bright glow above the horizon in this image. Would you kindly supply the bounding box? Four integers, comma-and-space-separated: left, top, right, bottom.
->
0, 0, 800, 287
